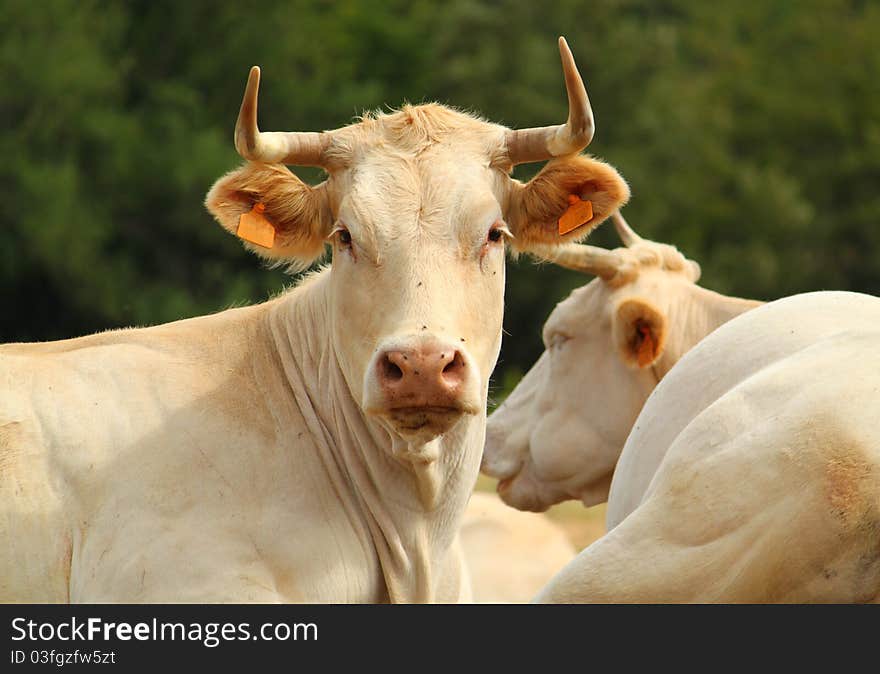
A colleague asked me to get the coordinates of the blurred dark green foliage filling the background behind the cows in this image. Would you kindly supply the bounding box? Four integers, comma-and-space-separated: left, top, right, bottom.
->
0, 0, 880, 388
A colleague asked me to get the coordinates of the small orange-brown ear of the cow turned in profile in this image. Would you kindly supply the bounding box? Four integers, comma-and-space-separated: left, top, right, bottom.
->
611, 298, 666, 367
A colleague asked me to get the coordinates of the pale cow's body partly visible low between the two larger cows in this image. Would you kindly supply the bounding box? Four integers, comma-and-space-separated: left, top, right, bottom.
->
461, 492, 577, 603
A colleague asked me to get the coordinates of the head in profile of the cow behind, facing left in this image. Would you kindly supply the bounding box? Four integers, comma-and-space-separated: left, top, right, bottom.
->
482, 213, 700, 510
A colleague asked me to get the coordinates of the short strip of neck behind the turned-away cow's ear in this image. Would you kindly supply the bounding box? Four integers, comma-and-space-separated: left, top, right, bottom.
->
654, 284, 762, 381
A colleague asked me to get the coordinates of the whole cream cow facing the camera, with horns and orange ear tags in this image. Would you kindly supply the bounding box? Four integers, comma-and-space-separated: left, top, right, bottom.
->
0, 40, 628, 602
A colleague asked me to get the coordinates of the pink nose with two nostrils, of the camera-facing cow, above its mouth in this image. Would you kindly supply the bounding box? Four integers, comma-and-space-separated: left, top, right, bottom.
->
378, 345, 468, 407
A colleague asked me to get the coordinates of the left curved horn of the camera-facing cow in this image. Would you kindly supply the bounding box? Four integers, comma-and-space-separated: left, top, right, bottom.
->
235, 66, 330, 166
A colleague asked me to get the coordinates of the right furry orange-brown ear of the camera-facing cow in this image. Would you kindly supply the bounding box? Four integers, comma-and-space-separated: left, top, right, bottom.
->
505, 156, 629, 251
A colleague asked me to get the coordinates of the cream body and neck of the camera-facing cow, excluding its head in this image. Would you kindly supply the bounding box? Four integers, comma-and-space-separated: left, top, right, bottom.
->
0, 274, 483, 602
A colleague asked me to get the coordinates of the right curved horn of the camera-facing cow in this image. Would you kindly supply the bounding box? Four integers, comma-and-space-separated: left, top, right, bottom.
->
506, 37, 595, 165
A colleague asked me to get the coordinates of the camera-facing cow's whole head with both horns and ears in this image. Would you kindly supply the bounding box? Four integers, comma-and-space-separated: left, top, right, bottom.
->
206, 38, 629, 442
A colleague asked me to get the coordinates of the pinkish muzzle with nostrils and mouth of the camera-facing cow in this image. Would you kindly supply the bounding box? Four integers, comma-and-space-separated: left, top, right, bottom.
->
364, 338, 480, 442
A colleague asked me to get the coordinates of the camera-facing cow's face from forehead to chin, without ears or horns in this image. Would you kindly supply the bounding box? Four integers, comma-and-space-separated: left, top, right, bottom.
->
331, 136, 512, 440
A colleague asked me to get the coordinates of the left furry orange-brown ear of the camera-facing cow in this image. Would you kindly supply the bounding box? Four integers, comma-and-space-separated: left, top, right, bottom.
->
205, 162, 333, 268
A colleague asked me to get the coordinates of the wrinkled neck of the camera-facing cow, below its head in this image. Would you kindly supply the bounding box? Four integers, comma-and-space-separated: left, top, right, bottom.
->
270, 272, 485, 602
